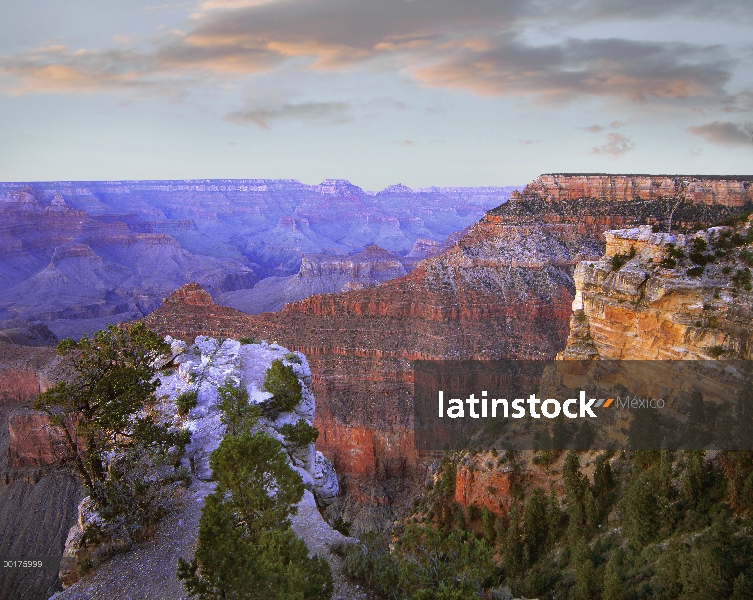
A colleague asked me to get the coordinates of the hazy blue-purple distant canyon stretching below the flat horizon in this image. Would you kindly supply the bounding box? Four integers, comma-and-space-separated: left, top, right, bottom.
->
0, 179, 517, 338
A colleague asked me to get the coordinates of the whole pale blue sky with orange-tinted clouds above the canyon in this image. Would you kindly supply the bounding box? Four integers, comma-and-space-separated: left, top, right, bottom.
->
0, 0, 753, 190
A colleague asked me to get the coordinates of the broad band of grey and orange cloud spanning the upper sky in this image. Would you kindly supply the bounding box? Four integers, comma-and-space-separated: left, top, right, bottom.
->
0, 0, 753, 106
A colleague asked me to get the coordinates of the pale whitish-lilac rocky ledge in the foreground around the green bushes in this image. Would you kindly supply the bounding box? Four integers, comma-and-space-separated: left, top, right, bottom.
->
55, 336, 361, 600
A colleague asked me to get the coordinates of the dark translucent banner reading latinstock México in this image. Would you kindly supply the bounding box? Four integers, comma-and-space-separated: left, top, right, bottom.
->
413, 360, 753, 452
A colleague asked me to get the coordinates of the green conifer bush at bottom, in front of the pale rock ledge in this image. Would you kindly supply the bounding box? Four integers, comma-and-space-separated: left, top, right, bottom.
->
178, 382, 333, 600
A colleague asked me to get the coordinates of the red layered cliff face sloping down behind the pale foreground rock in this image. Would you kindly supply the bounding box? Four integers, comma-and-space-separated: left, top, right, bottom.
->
140, 177, 742, 526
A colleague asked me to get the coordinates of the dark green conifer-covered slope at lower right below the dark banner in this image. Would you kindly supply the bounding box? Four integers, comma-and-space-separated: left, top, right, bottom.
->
345, 446, 753, 600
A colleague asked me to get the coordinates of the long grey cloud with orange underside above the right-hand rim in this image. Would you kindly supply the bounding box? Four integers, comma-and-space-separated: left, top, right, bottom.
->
413, 36, 731, 102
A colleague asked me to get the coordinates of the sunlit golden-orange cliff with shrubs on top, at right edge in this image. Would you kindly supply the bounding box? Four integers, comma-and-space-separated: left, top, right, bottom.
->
561, 220, 753, 360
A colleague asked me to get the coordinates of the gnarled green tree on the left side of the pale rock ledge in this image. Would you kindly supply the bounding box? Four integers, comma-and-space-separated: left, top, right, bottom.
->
34, 323, 189, 537
